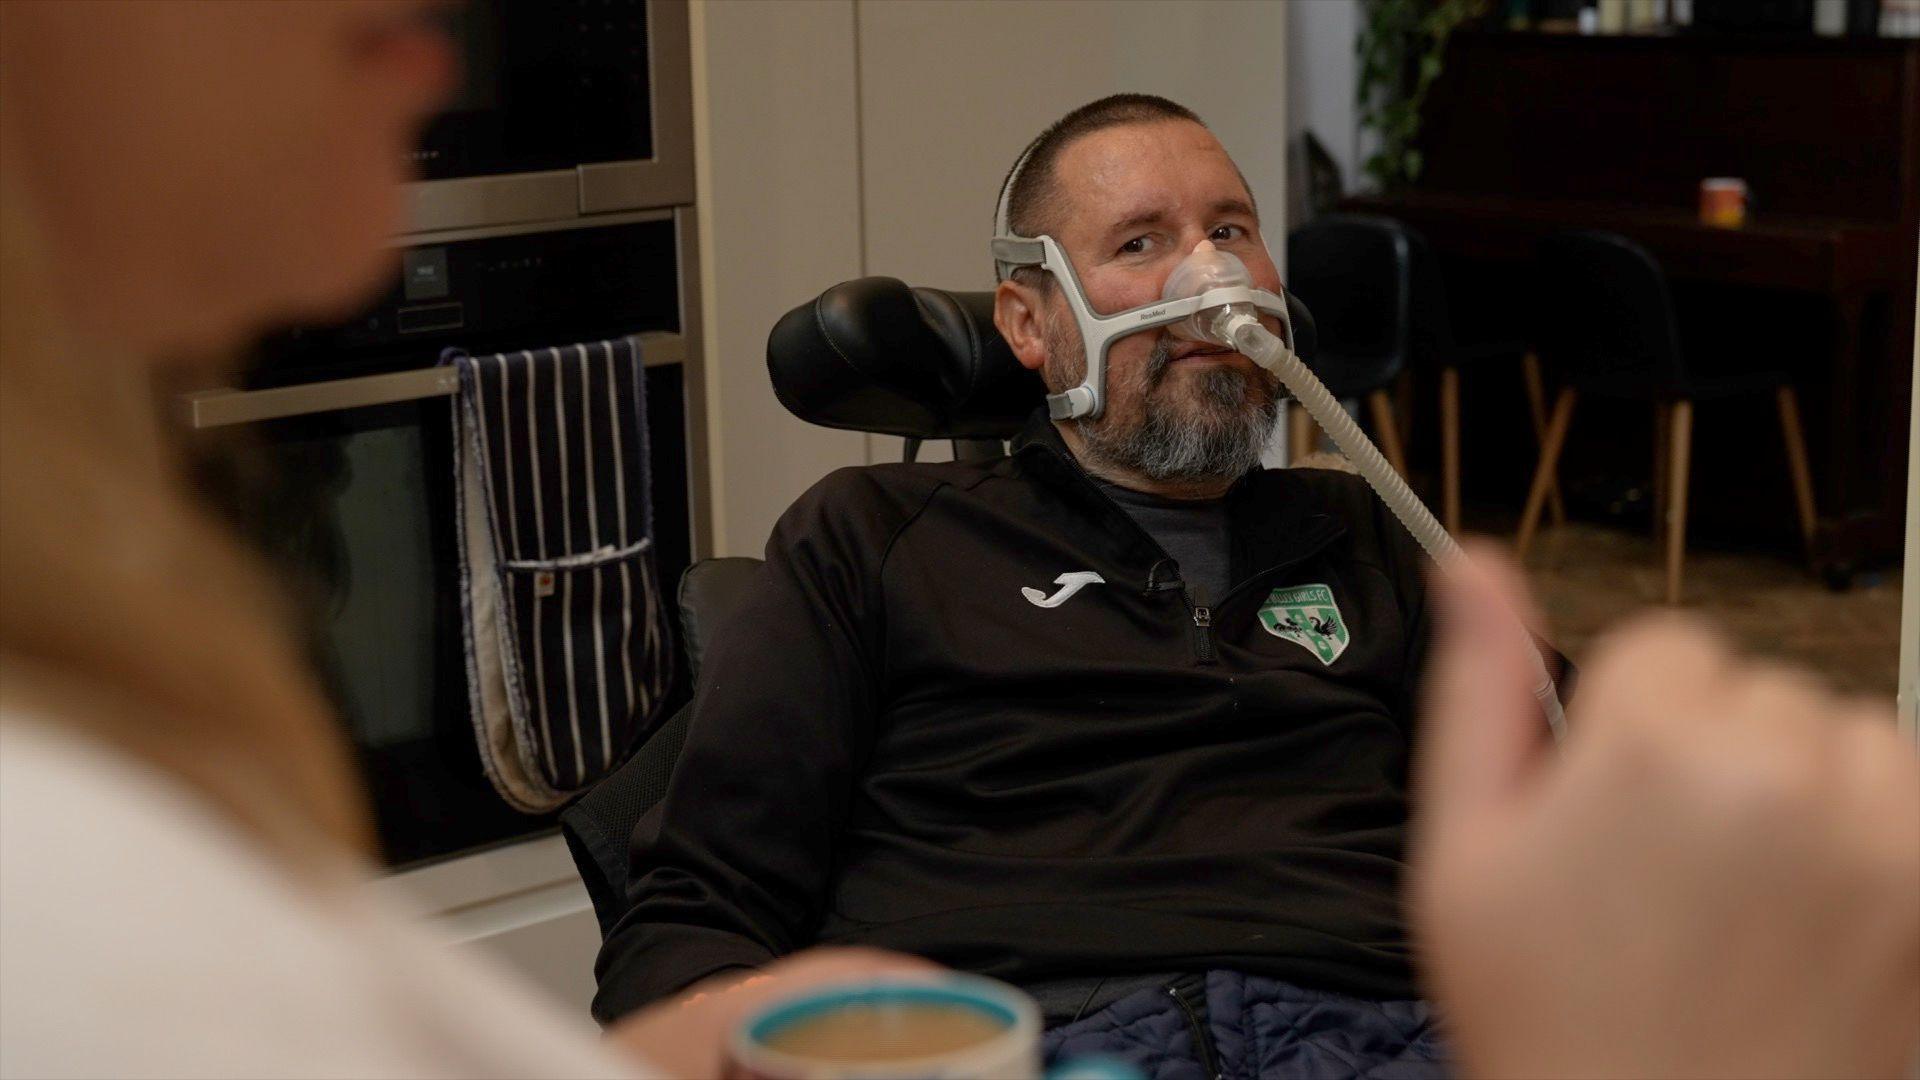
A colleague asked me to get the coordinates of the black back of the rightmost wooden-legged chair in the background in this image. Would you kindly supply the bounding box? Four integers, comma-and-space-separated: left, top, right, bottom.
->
1530, 231, 1688, 396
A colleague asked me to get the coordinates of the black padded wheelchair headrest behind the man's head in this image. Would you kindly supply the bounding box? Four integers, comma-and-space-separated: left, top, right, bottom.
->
766, 277, 1315, 438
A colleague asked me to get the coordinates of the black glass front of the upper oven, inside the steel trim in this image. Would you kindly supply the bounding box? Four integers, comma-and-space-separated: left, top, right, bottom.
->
415, 0, 655, 181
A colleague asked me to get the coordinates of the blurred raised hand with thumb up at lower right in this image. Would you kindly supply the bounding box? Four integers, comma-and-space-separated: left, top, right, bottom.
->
1411, 552, 1920, 1076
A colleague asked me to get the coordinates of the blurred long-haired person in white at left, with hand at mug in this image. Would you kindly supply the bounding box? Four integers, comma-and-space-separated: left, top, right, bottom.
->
0, 0, 924, 1076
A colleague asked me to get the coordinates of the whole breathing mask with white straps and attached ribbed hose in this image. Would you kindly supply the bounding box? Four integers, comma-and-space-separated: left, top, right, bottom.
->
993, 158, 1567, 738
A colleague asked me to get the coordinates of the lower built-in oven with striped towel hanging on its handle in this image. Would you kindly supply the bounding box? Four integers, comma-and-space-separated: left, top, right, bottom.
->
182, 208, 705, 867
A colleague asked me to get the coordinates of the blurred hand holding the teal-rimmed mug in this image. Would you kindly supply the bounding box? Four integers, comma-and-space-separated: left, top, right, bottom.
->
607, 947, 943, 1076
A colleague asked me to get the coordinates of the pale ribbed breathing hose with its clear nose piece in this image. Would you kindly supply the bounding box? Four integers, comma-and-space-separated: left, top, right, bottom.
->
1162, 240, 1567, 738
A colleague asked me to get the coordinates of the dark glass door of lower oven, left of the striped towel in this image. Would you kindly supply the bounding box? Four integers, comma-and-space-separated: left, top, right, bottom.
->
209, 398, 551, 865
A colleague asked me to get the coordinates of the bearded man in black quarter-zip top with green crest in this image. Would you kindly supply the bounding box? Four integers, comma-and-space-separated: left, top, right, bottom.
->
595, 94, 1559, 1076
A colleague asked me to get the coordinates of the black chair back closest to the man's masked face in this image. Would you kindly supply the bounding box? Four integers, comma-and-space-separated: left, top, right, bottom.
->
1286, 213, 1413, 398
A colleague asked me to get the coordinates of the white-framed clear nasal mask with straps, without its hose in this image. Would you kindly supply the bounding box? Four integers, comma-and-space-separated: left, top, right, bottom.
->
993, 158, 1294, 421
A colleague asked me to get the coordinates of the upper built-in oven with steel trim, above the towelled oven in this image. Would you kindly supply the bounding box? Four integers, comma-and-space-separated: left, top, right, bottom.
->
409, 0, 693, 231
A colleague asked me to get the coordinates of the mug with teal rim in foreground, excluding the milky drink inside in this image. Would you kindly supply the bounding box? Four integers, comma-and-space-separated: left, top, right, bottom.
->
728, 974, 1041, 1080
